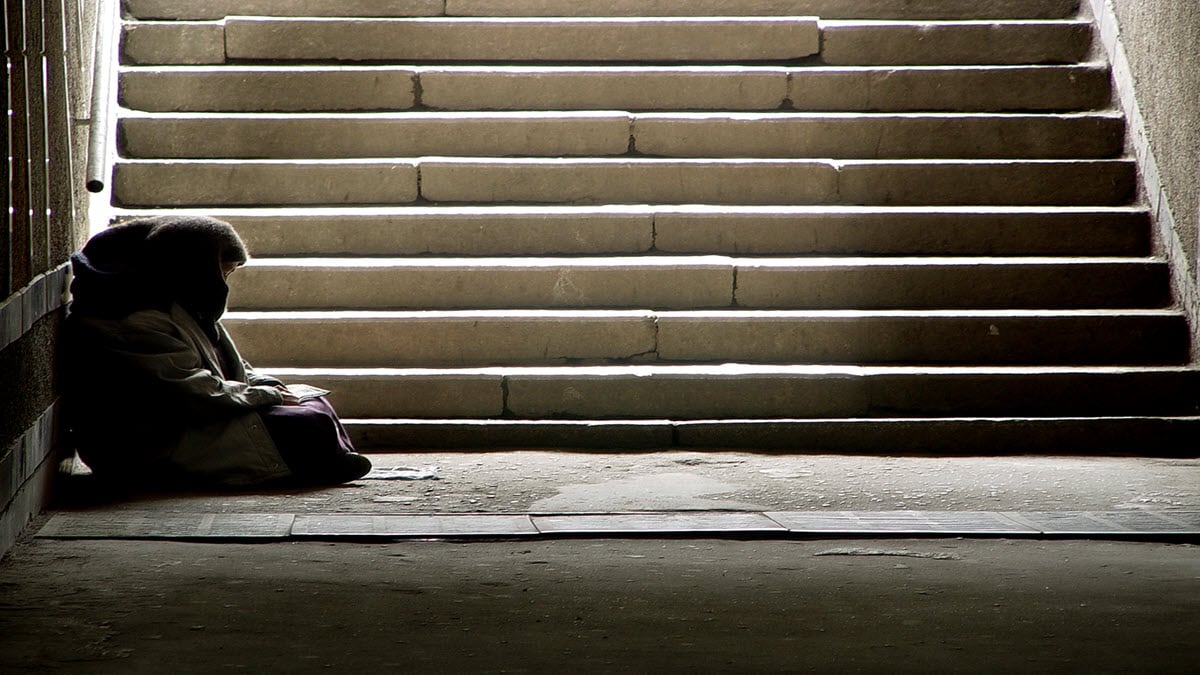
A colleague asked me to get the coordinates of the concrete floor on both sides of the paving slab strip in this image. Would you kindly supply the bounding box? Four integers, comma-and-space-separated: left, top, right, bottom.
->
0, 452, 1200, 673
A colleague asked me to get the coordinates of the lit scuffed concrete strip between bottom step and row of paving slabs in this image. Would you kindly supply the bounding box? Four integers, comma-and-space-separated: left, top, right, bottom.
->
51, 450, 1200, 513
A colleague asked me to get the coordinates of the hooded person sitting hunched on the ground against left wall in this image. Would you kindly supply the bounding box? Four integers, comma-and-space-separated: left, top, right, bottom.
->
64, 216, 371, 486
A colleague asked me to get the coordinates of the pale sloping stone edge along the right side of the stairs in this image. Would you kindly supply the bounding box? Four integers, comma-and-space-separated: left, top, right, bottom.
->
1081, 0, 1200, 363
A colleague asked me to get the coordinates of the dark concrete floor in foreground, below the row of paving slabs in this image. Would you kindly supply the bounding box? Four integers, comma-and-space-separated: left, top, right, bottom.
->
0, 539, 1200, 674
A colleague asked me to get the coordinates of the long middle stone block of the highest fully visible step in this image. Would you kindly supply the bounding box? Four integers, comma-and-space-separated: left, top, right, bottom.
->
220, 17, 818, 62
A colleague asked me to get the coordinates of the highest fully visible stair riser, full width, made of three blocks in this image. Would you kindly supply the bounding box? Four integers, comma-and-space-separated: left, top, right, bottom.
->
122, 18, 1091, 66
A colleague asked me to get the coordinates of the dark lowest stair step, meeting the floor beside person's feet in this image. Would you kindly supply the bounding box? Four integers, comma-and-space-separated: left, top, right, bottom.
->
343, 417, 1200, 458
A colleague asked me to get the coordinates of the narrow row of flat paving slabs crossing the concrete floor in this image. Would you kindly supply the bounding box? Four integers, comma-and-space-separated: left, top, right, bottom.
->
36, 510, 1200, 540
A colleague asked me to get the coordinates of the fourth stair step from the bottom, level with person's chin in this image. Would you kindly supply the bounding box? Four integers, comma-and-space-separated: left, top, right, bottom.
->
230, 256, 1170, 310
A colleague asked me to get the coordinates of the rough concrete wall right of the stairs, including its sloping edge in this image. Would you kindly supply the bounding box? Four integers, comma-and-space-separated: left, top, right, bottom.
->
1088, 0, 1200, 354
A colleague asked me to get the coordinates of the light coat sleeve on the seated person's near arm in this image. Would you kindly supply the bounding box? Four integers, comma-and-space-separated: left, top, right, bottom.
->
99, 312, 283, 414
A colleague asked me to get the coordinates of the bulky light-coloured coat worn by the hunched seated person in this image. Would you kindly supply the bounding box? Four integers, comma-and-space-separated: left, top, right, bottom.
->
67, 300, 290, 486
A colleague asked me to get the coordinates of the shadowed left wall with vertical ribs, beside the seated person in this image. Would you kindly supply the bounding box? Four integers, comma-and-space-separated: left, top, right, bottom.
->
0, 0, 96, 555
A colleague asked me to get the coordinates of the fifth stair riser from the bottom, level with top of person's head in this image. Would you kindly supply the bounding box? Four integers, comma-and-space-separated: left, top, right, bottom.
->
210, 208, 1150, 257
